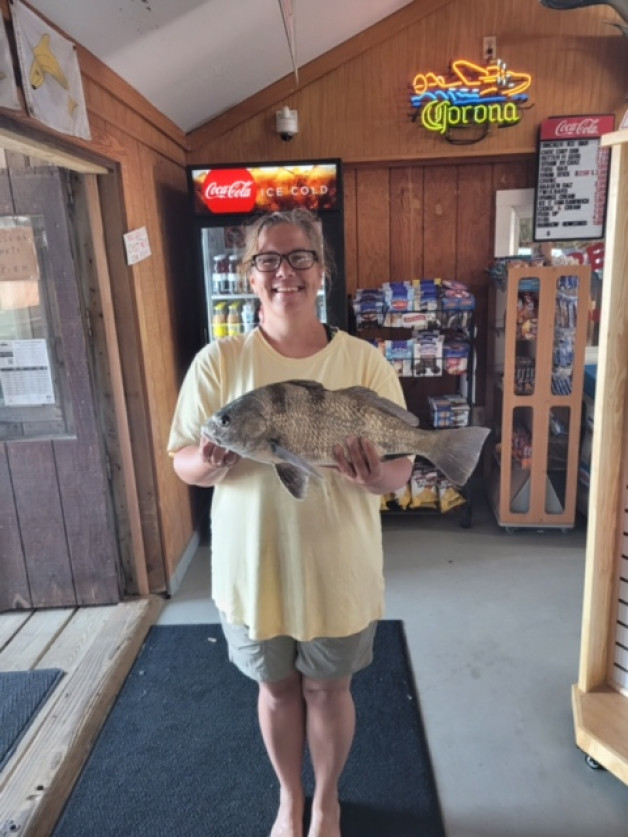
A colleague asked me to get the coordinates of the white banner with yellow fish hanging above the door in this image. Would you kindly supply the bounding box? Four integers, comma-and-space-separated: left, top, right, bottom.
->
12, 0, 92, 139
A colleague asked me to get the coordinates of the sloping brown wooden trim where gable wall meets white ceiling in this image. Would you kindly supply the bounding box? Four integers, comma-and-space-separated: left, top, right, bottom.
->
187, 0, 454, 152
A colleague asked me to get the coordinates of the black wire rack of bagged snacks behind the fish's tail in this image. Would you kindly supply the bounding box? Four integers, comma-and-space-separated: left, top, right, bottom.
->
350, 280, 475, 528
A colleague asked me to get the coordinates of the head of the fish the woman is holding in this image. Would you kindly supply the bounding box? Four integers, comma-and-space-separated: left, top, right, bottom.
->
201, 393, 271, 459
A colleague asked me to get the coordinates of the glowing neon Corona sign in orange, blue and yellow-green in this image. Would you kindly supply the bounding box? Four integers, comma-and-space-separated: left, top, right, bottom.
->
410, 58, 532, 134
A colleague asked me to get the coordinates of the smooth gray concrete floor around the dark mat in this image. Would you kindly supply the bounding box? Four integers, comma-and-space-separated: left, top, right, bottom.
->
159, 491, 628, 837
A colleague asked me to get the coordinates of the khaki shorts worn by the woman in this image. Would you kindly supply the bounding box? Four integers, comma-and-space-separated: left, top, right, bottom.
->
220, 613, 377, 683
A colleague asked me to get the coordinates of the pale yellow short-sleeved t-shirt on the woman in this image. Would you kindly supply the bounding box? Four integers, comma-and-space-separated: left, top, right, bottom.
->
168, 329, 405, 640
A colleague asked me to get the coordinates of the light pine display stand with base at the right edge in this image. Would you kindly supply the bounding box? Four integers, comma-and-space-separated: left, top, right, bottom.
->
572, 130, 628, 784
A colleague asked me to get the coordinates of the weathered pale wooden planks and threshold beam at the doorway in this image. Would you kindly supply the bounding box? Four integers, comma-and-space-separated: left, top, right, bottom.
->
0, 596, 163, 837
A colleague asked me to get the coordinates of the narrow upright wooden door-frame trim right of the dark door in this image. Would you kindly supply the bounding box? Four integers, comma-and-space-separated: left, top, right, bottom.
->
85, 177, 149, 596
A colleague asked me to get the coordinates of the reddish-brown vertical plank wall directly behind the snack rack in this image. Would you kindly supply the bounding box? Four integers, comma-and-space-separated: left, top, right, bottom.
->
344, 155, 536, 404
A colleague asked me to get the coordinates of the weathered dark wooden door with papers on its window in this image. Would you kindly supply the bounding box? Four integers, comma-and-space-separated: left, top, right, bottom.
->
0, 166, 121, 610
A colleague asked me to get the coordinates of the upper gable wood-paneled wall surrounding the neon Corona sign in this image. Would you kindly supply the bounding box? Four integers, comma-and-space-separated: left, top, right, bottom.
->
189, 0, 628, 164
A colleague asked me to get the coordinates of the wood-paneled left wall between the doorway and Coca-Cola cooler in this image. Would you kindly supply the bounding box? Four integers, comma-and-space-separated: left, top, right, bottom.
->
0, 0, 201, 593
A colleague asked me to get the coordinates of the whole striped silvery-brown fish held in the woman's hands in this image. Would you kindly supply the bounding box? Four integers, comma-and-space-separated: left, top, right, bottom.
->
201, 380, 490, 500
